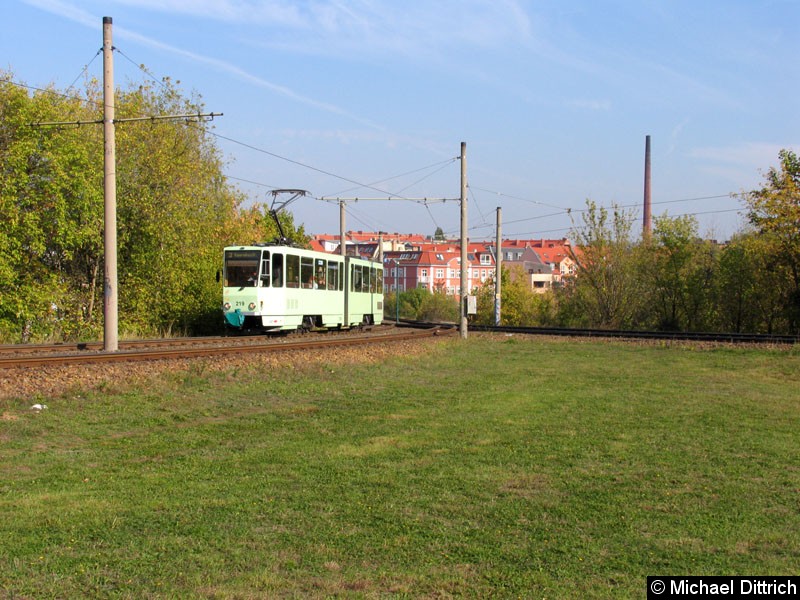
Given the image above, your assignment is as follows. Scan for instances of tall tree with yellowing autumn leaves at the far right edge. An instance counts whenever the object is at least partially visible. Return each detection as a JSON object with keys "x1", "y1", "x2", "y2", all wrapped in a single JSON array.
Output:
[{"x1": 745, "y1": 150, "x2": 800, "y2": 333}]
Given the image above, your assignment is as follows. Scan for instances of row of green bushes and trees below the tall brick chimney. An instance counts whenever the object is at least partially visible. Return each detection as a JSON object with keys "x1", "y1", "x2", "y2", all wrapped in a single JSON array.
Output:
[{"x1": 428, "y1": 150, "x2": 800, "y2": 335}]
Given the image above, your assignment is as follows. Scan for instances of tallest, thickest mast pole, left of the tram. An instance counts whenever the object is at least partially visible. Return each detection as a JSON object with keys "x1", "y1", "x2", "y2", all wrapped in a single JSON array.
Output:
[{"x1": 103, "y1": 17, "x2": 119, "y2": 352}]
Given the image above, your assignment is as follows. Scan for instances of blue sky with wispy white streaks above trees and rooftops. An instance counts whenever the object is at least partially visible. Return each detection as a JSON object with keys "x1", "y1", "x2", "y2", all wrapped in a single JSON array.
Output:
[{"x1": 0, "y1": 0, "x2": 800, "y2": 240}]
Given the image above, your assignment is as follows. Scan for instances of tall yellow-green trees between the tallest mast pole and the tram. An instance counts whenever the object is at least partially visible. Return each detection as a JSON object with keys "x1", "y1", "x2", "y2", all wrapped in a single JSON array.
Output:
[{"x1": 111, "y1": 81, "x2": 242, "y2": 332}]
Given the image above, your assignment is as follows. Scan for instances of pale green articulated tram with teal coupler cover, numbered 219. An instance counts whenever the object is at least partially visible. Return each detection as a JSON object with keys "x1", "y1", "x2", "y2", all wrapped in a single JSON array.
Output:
[{"x1": 222, "y1": 244, "x2": 383, "y2": 332}]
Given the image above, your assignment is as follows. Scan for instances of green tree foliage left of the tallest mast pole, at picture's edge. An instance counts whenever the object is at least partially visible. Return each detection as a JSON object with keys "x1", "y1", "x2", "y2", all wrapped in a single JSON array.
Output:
[{"x1": 0, "y1": 75, "x2": 102, "y2": 339}]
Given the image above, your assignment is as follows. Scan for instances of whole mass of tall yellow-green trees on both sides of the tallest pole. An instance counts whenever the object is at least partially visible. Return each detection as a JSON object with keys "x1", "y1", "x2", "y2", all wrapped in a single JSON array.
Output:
[{"x1": 0, "y1": 74, "x2": 307, "y2": 340}]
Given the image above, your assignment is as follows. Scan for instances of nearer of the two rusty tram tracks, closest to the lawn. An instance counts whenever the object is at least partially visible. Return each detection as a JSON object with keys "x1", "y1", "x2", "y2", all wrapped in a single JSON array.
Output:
[{"x1": 0, "y1": 327, "x2": 450, "y2": 369}]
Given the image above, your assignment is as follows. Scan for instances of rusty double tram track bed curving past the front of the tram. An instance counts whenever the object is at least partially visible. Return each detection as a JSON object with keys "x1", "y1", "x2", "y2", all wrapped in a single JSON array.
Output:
[{"x1": 0, "y1": 326, "x2": 450, "y2": 369}]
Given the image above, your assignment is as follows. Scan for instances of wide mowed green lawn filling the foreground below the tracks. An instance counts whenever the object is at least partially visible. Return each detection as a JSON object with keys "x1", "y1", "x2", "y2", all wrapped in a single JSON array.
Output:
[{"x1": 0, "y1": 335, "x2": 800, "y2": 598}]
